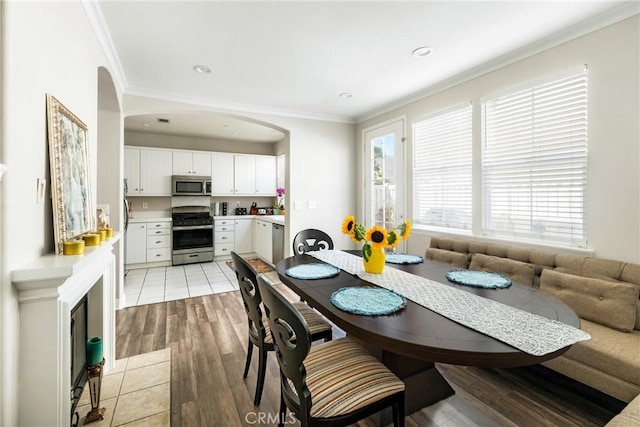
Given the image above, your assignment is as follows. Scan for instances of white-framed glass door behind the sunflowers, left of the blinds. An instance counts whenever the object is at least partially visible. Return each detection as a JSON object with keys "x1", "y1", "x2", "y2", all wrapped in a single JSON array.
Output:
[{"x1": 364, "y1": 118, "x2": 405, "y2": 251}]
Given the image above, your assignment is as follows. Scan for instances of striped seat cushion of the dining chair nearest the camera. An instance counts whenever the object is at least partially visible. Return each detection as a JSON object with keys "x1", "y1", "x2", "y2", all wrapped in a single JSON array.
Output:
[{"x1": 302, "y1": 337, "x2": 404, "y2": 418}]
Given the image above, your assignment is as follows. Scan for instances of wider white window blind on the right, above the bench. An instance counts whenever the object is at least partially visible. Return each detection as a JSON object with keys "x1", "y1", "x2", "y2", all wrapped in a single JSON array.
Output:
[{"x1": 482, "y1": 69, "x2": 587, "y2": 247}]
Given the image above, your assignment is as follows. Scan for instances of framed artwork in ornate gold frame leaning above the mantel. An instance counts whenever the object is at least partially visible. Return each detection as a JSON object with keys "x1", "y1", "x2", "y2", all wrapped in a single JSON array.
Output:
[{"x1": 47, "y1": 94, "x2": 96, "y2": 254}]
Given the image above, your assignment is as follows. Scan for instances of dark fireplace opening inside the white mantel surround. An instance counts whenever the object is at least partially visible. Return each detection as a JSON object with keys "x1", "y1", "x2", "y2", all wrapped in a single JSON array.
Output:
[{"x1": 71, "y1": 295, "x2": 88, "y2": 426}]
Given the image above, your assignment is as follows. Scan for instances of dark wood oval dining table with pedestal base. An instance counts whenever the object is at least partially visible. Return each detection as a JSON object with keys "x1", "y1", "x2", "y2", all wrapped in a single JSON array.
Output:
[{"x1": 276, "y1": 251, "x2": 580, "y2": 414}]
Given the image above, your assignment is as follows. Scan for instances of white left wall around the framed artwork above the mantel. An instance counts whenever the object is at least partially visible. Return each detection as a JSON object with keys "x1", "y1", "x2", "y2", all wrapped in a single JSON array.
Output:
[{"x1": 0, "y1": 1, "x2": 119, "y2": 426}]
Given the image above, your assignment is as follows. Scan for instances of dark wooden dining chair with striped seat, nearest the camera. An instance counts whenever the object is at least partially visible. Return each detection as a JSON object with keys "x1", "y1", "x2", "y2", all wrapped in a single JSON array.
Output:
[{"x1": 258, "y1": 274, "x2": 405, "y2": 427}]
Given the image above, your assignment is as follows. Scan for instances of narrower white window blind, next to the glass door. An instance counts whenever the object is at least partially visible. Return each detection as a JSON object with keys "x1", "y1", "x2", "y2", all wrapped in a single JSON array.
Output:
[{"x1": 413, "y1": 104, "x2": 472, "y2": 232}]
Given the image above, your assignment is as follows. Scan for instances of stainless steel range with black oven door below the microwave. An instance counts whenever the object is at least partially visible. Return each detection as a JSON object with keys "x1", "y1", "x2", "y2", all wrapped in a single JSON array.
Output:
[{"x1": 171, "y1": 211, "x2": 213, "y2": 265}]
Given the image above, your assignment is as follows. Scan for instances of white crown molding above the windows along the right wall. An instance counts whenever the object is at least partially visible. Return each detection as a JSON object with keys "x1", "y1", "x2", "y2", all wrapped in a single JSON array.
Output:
[{"x1": 356, "y1": 1, "x2": 640, "y2": 123}]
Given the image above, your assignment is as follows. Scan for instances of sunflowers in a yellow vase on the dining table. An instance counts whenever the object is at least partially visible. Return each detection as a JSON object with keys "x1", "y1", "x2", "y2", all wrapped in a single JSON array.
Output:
[{"x1": 342, "y1": 215, "x2": 411, "y2": 274}]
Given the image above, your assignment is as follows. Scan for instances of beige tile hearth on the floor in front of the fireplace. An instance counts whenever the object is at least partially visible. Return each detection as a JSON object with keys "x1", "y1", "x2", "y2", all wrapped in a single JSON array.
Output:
[{"x1": 76, "y1": 348, "x2": 171, "y2": 427}]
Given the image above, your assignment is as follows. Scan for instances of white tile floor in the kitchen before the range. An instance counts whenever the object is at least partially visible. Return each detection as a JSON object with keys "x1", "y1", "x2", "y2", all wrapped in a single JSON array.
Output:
[{"x1": 124, "y1": 261, "x2": 238, "y2": 307}]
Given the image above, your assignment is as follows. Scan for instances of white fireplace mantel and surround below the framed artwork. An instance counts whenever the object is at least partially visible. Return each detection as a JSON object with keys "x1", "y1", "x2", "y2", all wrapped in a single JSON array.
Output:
[{"x1": 11, "y1": 233, "x2": 122, "y2": 426}]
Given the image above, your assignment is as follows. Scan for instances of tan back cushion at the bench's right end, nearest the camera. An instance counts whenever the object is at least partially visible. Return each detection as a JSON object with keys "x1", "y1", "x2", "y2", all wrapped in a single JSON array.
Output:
[{"x1": 540, "y1": 270, "x2": 638, "y2": 332}]
